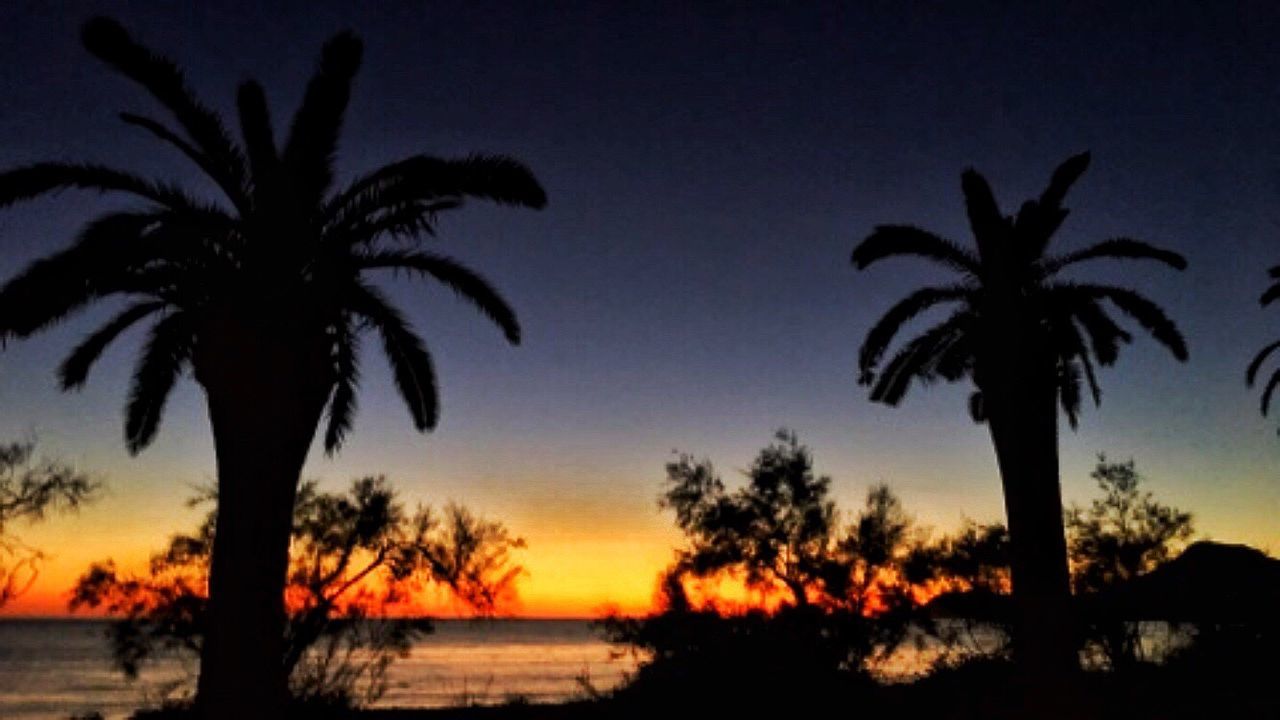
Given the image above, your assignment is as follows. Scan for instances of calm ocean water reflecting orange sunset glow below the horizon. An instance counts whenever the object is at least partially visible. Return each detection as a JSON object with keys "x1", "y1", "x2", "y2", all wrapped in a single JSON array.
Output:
[{"x1": 0, "y1": 619, "x2": 635, "y2": 720}]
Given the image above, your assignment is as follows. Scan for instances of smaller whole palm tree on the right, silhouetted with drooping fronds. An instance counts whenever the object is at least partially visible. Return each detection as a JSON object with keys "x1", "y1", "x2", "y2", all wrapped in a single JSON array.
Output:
[{"x1": 852, "y1": 154, "x2": 1187, "y2": 678}]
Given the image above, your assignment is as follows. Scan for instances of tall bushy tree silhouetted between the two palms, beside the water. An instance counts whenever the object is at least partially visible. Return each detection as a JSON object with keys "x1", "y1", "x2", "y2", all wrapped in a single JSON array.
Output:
[{"x1": 602, "y1": 430, "x2": 914, "y2": 715}]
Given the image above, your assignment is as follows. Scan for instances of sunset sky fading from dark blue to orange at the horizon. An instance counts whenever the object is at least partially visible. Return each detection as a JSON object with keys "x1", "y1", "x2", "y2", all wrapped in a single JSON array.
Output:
[{"x1": 0, "y1": 1, "x2": 1280, "y2": 616}]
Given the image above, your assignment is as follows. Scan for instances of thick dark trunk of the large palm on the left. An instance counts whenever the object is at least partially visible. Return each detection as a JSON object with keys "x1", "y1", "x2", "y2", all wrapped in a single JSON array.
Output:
[{"x1": 196, "y1": 320, "x2": 328, "y2": 720}]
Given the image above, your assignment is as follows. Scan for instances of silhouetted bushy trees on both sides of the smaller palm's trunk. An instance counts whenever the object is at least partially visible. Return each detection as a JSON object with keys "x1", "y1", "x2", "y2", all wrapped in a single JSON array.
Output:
[{"x1": 603, "y1": 430, "x2": 1194, "y2": 703}]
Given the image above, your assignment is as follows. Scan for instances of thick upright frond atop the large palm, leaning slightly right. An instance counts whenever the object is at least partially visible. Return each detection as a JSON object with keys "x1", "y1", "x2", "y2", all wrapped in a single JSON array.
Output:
[{"x1": 280, "y1": 31, "x2": 364, "y2": 205}]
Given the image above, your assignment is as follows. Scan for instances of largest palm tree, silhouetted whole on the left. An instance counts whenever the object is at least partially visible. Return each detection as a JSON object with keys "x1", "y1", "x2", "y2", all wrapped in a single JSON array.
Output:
[{"x1": 0, "y1": 18, "x2": 547, "y2": 717}]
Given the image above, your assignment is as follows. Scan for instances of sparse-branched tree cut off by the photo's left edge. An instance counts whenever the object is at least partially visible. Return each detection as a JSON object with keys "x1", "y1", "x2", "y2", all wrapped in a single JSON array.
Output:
[{"x1": 0, "y1": 442, "x2": 101, "y2": 607}]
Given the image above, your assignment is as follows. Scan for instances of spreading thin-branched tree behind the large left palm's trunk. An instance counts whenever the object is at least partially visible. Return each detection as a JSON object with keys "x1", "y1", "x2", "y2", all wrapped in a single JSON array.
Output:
[{"x1": 70, "y1": 477, "x2": 524, "y2": 706}]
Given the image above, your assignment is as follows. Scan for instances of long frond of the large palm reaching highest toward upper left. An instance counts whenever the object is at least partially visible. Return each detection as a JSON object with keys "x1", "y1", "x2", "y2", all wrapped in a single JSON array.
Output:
[{"x1": 81, "y1": 17, "x2": 246, "y2": 206}]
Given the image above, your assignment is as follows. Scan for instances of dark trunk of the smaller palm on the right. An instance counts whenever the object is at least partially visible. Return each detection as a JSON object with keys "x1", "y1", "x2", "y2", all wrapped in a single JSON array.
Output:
[{"x1": 983, "y1": 363, "x2": 1079, "y2": 694}]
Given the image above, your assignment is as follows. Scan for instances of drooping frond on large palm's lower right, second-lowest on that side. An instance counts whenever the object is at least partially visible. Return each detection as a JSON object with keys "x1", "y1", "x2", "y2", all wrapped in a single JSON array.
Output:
[{"x1": 347, "y1": 284, "x2": 439, "y2": 430}]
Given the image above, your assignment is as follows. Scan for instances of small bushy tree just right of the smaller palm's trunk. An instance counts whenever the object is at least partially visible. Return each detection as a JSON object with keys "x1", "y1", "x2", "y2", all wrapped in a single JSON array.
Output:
[{"x1": 1066, "y1": 455, "x2": 1196, "y2": 669}]
